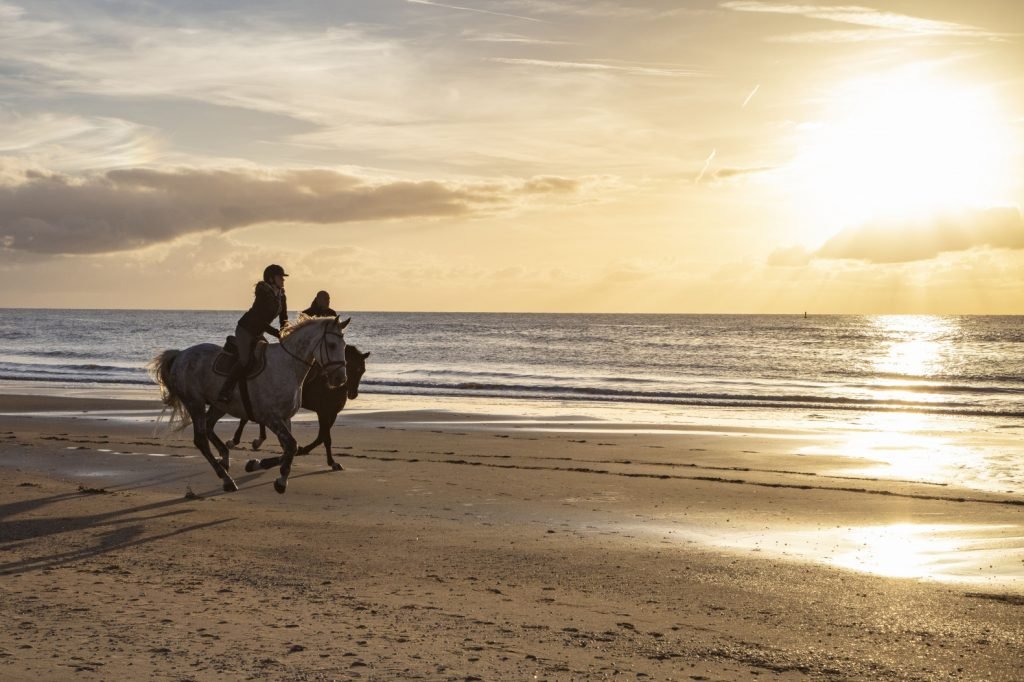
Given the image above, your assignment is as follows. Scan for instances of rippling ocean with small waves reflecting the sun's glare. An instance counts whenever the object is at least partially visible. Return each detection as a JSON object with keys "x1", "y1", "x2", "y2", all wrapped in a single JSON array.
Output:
[{"x1": 0, "y1": 309, "x2": 1024, "y2": 420}]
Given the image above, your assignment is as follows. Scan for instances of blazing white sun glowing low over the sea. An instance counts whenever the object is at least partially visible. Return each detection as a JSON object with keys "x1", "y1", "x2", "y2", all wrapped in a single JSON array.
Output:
[{"x1": 797, "y1": 70, "x2": 1011, "y2": 225}]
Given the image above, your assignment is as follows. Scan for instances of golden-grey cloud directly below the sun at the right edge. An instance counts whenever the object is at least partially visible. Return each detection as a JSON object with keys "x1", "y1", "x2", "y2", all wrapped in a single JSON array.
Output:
[{"x1": 814, "y1": 207, "x2": 1024, "y2": 263}]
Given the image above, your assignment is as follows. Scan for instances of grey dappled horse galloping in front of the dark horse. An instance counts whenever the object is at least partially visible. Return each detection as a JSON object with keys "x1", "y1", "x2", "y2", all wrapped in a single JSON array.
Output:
[{"x1": 150, "y1": 317, "x2": 350, "y2": 493}]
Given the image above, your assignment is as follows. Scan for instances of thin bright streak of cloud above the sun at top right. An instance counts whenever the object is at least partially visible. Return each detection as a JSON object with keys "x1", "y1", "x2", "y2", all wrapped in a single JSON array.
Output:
[{"x1": 719, "y1": 0, "x2": 1004, "y2": 41}]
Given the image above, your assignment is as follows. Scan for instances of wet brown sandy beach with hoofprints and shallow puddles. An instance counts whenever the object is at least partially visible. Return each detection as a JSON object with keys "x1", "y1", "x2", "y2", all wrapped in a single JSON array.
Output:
[{"x1": 0, "y1": 396, "x2": 1024, "y2": 680}]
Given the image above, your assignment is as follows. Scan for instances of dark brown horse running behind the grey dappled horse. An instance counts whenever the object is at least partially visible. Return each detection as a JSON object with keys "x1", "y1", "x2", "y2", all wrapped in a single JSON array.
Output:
[{"x1": 227, "y1": 346, "x2": 370, "y2": 471}]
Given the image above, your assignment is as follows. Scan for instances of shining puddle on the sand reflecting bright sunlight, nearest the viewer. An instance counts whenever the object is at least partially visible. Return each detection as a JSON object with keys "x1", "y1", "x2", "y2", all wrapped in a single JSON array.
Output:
[{"x1": 647, "y1": 523, "x2": 1024, "y2": 591}]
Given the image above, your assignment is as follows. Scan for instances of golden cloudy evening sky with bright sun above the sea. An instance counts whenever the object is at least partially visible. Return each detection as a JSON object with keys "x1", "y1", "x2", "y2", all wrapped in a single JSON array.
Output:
[{"x1": 0, "y1": 0, "x2": 1024, "y2": 314}]
